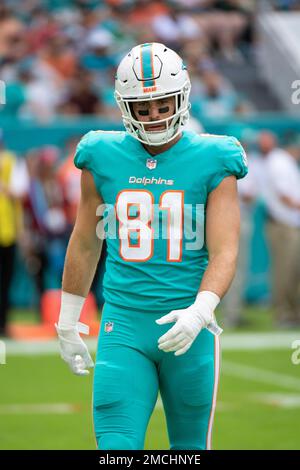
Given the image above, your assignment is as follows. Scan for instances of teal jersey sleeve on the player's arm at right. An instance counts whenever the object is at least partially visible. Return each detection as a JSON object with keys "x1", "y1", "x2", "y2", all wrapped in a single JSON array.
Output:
[{"x1": 208, "y1": 137, "x2": 248, "y2": 192}]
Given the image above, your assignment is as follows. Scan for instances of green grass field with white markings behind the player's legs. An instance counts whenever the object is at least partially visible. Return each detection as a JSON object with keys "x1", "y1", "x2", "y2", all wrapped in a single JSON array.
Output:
[{"x1": 0, "y1": 306, "x2": 300, "y2": 449}]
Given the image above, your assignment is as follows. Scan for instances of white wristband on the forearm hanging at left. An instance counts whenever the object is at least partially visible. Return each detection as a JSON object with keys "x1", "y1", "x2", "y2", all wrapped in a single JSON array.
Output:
[{"x1": 58, "y1": 291, "x2": 85, "y2": 329}]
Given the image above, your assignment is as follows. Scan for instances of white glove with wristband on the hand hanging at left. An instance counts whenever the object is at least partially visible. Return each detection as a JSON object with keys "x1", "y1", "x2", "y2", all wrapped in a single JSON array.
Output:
[{"x1": 55, "y1": 292, "x2": 94, "y2": 375}]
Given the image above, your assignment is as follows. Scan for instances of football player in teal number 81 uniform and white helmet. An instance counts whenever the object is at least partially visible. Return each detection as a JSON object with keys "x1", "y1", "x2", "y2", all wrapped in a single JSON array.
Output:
[{"x1": 57, "y1": 43, "x2": 247, "y2": 450}]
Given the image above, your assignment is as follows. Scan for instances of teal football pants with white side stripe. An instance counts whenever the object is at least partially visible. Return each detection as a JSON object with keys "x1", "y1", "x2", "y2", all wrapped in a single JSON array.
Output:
[{"x1": 93, "y1": 303, "x2": 219, "y2": 450}]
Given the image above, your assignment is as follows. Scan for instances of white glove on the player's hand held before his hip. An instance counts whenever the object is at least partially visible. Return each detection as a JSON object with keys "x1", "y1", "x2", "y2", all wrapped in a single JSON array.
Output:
[{"x1": 156, "y1": 291, "x2": 222, "y2": 356}]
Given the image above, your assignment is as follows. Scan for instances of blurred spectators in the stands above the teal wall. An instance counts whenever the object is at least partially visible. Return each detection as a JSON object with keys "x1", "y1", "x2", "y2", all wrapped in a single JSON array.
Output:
[{"x1": 0, "y1": 0, "x2": 256, "y2": 121}]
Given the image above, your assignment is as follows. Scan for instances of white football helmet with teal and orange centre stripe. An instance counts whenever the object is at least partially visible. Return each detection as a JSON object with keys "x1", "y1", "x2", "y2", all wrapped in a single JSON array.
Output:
[{"x1": 115, "y1": 42, "x2": 191, "y2": 145}]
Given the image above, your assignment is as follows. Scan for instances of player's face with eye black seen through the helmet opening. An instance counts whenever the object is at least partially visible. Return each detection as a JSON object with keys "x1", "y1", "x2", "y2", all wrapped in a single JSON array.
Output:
[{"x1": 132, "y1": 96, "x2": 175, "y2": 132}]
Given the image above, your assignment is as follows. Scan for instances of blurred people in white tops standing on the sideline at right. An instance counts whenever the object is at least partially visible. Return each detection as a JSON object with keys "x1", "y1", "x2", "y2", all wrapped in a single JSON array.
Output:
[{"x1": 223, "y1": 130, "x2": 300, "y2": 328}]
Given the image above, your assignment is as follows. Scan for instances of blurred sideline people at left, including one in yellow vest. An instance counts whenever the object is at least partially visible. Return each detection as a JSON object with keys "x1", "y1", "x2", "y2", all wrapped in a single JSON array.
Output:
[{"x1": 0, "y1": 129, "x2": 80, "y2": 334}]
